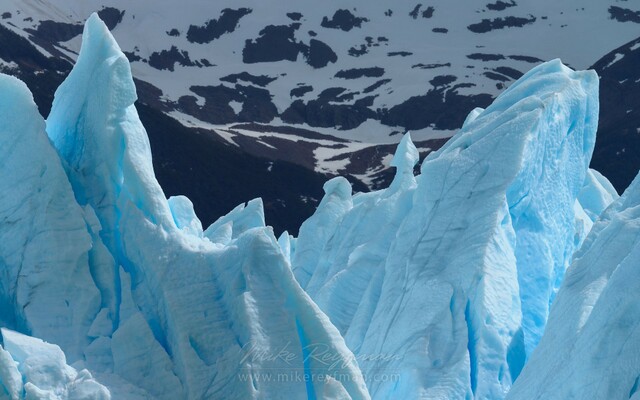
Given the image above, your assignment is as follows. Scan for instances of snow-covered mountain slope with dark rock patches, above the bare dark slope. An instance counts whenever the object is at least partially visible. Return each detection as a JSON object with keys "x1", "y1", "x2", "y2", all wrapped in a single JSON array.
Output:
[{"x1": 0, "y1": 0, "x2": 638, "y2": 180}]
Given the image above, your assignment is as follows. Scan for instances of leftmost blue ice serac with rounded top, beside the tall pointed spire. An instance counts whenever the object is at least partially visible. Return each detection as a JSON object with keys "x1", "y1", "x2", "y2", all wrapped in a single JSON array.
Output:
[{"x1": 0, "y1": 75, "x2": 108, "y2": 362}]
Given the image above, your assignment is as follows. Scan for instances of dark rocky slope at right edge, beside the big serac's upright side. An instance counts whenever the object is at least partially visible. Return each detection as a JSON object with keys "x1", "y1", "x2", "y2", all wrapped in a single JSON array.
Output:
[{"x1": 591, "y1": 38, "x2": 640, "y2": 193}]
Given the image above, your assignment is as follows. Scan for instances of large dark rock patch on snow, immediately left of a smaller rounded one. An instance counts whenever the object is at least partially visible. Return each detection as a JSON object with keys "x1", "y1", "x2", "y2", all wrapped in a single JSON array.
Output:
[{"x1": 242, "y1": 24, "x2": 306, "y2": 64}]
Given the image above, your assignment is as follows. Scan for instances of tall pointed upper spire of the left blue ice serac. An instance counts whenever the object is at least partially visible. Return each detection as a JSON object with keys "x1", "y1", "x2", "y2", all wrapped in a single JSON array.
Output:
[{"x1": 47, "y1": 14, "x2": 175, "y2": 250}]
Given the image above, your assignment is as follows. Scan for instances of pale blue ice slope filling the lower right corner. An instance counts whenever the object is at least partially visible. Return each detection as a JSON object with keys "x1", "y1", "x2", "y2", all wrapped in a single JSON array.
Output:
[{"x1": 507, "y1": 173, "x2": 640, "y2": 400}]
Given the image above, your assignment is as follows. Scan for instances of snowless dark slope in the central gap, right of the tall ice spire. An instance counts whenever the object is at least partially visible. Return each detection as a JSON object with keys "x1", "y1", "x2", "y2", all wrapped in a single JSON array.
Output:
[{"x1": 136, "y1": 103, "x2": 328, "y2": 235}]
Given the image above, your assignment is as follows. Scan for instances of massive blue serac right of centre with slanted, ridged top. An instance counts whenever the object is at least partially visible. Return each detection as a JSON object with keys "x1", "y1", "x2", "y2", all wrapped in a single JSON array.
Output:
[{"x1": 293, "y1": 60, "x2": 613, "y2": 399}]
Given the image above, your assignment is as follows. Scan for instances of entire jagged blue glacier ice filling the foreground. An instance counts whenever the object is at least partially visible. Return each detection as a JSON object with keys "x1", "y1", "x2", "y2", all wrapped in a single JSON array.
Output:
[{"x1": 0, "y1": 10, "x2": 640, "y2": 400}]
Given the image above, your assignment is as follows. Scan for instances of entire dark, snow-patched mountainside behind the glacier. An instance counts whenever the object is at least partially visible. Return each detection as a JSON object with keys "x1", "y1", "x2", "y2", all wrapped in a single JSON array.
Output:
[{"x1": 0, "y1": 0, "x2": 640, "y2": 233}]
